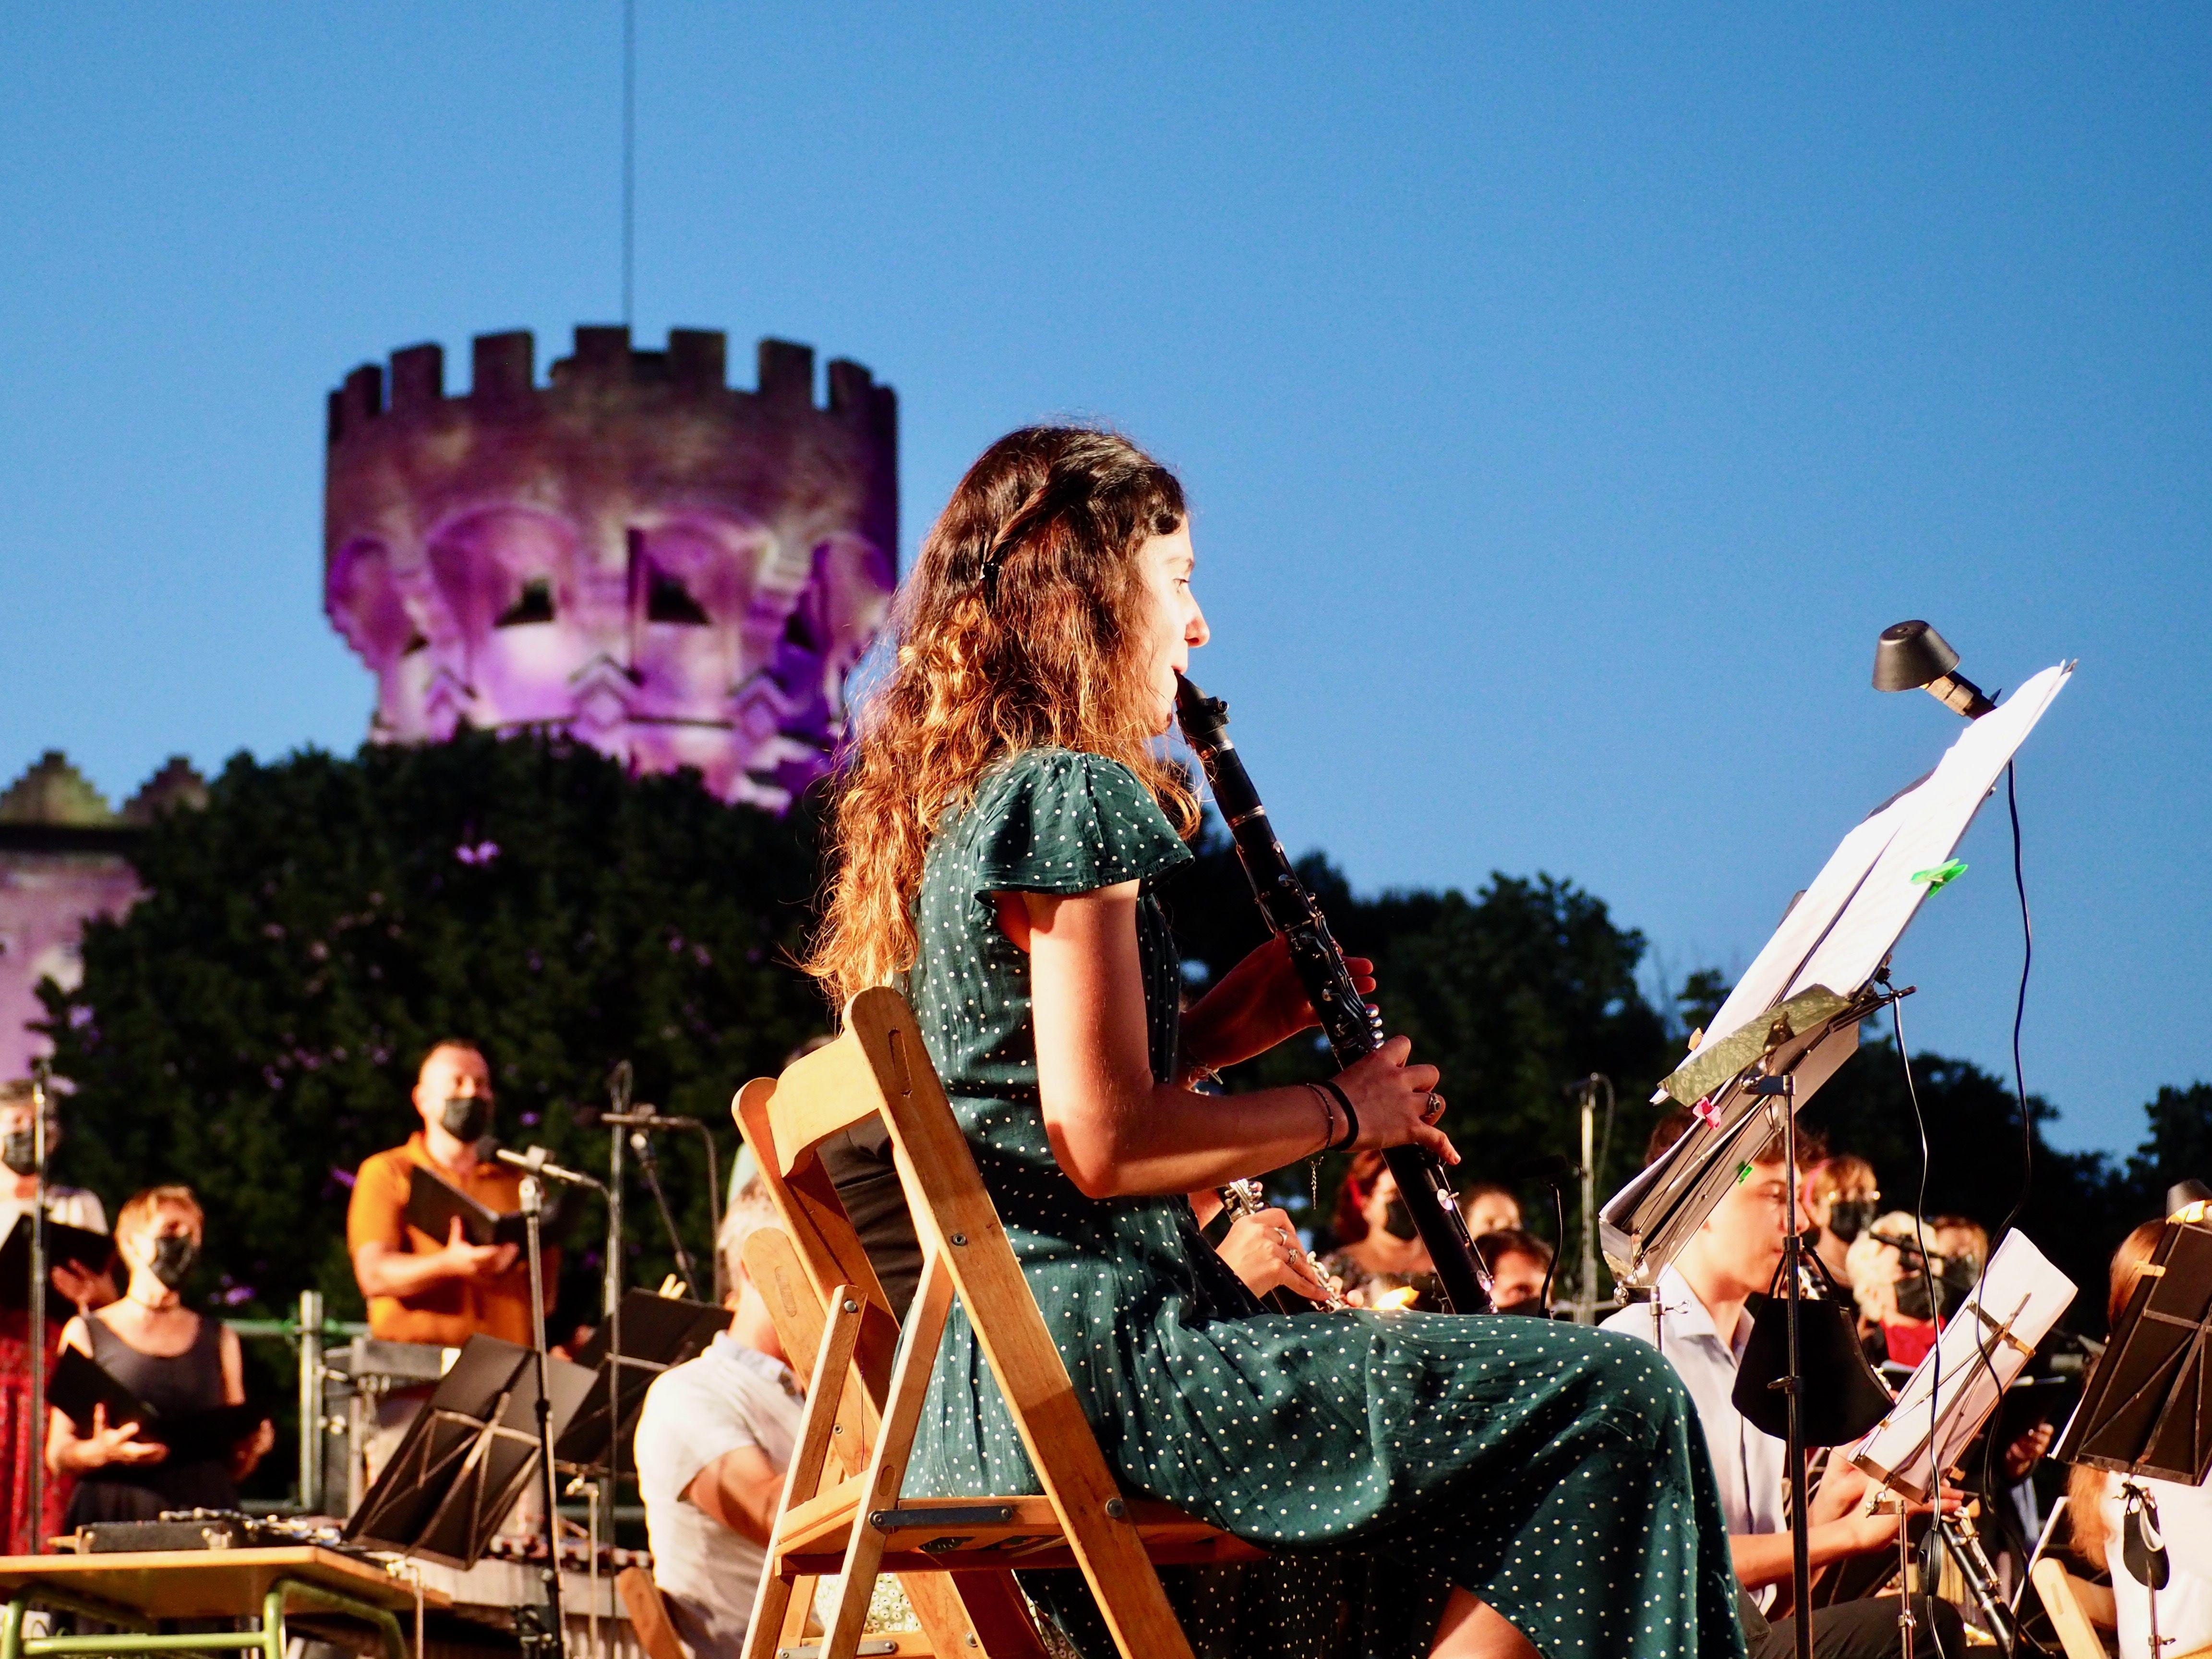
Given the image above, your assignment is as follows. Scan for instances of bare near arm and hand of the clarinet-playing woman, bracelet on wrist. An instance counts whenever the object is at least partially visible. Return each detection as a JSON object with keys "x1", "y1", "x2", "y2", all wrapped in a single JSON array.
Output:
[{"x1": 1009, "y1": 883, "x2": 1455, "y2": 1199}]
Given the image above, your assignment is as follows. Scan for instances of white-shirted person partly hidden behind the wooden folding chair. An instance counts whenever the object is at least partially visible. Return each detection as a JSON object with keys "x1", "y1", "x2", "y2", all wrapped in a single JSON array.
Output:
[{"x1": 637, "y1": 1181, "x2": 801, "y2": 1659}]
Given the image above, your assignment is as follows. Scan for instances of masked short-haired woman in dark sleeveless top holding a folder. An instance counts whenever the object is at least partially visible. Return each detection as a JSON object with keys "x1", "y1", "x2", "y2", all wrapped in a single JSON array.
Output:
[{"x1": 47, "y1": 1186, "x2": 274, "y2": 1527}]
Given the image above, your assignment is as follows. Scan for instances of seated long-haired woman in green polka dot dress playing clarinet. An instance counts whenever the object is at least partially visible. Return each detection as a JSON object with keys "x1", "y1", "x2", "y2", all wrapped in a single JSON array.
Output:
[{"x1": 812, "y1": 429, "x2": 1741, "y2": 1659}]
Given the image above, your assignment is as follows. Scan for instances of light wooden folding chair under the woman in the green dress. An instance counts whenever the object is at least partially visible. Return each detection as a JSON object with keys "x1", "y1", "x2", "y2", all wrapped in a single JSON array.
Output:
[{"x1": 732, "y1": 989, "x2": 1263, "y2": 1659}]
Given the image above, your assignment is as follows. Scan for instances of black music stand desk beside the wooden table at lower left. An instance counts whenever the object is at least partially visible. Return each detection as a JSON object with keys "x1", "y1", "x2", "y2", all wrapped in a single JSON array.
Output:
[{"x1": 345, "y1": 1336, "x2": 593, "y2": 1571}]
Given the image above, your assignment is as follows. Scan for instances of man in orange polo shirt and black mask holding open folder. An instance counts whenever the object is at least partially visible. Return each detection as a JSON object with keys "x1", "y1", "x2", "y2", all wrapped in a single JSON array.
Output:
[{"x1": 345, "y1": 1040, "x2": 560, "y2": 1347}]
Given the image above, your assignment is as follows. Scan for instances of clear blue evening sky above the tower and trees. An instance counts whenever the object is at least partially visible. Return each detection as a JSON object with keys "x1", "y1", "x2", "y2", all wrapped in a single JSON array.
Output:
[{"x1": 0, "y1": 0, "x2": 2212, "y2": 1150}]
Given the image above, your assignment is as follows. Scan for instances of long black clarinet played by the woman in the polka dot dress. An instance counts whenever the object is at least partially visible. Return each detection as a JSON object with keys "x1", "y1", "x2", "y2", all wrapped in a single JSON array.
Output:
[{"x1": 1175, "y1": 674, "x2": 1491, "y2": 1314}]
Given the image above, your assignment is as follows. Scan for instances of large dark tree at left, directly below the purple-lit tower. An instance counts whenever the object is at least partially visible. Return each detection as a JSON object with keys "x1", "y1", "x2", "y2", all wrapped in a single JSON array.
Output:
[{"x1": 47, "y1": 734, "x2": 825, "y2": 1318}]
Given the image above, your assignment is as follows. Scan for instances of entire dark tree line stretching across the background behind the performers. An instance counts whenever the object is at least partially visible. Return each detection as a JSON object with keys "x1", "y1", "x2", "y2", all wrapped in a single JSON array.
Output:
[{"x1": 26, "y1": 734, "x2": 2212, "y2": 1345}]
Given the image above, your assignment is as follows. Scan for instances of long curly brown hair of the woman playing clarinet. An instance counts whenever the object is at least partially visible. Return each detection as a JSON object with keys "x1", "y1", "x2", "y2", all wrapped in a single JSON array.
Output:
[{"x1": 805, "y1": 427, "x2": 1199, "y2": 1007}]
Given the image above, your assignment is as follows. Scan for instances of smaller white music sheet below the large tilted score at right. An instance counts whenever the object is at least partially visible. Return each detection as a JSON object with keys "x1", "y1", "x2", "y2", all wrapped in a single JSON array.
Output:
[{"x1": 1851, "y1": 1227, "x2": 2075, "y2": 1504}]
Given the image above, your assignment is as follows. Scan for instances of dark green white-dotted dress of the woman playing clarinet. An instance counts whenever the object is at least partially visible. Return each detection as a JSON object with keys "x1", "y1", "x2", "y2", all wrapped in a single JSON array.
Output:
[{"x1": 907, "y1": 750, "x2": 1743, "y2": 1659}]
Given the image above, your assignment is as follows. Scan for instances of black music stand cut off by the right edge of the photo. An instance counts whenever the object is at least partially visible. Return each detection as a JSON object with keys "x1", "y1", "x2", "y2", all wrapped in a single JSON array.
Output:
[{"x1": 2057, "y1": 1221, "x2": 2212, "y2": 1659}]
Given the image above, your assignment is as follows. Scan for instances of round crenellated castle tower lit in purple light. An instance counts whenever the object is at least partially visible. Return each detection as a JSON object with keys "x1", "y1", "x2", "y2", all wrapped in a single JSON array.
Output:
[{"x1": 323, "y1": 327, "x2": 898, "y2": 810}]
